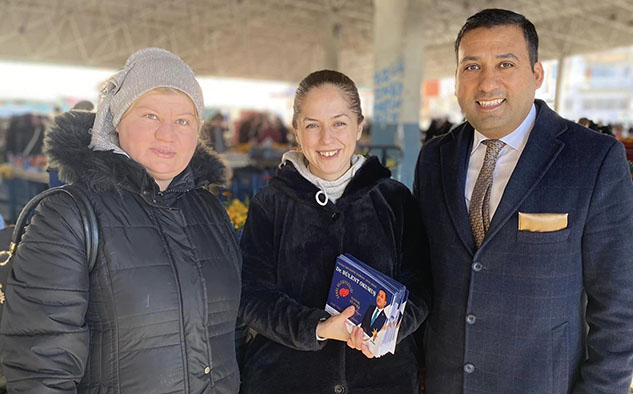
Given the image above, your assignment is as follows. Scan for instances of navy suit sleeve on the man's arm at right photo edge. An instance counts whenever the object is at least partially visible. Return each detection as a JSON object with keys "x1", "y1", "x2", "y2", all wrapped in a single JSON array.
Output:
[{"x1": 573, "y1": 142, "x2": 633, "y2": 394}]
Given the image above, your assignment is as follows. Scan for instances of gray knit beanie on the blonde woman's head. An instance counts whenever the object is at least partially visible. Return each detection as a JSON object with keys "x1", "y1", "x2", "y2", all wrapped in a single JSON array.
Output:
[{"x1": 90, "y1": 48, "x2": 204, "y2": 156}]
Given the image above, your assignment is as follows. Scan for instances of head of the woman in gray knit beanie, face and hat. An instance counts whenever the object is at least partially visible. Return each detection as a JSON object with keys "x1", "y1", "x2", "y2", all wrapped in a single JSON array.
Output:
[{"x1": 90, "y1": 48, "x2": 204, "y2": 190}]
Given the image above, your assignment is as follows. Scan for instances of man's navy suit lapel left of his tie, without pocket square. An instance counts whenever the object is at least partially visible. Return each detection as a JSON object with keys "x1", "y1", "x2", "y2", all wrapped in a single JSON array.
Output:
[{"x1": 440, "y1": 123, "x2": 475, "y2": 253}]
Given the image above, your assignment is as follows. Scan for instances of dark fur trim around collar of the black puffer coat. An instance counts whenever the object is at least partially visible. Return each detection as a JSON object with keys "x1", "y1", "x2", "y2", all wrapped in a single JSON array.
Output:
[{"x1": 44, "y1": 111, "x2": 227, "y2": 191}]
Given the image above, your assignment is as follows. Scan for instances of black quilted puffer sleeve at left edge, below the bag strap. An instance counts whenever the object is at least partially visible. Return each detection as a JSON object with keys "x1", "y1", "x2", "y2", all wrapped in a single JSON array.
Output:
[{"x1": 0, "y1": 195, "x2": 89, "y2": 394}]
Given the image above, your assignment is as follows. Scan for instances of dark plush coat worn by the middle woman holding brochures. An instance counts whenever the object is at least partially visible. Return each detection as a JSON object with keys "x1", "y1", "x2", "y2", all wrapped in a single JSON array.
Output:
[{"x1": 240, "y1": 157, "x2": 429, "y2": 394}]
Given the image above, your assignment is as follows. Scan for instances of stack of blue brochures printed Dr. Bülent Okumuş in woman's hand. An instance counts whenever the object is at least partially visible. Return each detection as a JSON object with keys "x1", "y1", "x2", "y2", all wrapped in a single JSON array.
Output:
[{"x1": 325, "y1": 254, "x2": 409, "y2": 357}]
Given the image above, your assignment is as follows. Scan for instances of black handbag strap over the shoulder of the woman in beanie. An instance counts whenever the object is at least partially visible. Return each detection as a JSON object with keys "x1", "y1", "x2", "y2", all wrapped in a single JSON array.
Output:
[{"x1": 0, "y1": 185, "x2": 99, "y2": 272}]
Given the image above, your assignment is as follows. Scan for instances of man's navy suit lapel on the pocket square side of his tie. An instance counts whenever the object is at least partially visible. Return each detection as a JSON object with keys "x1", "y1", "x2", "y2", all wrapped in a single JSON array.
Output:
[{"x1": 480, "y1": 100, "x2": 567, "y2": 249}]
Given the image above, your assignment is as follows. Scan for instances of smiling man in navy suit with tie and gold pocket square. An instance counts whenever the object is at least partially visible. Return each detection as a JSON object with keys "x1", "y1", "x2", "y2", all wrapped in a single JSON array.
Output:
[{"x1": 414, "y1": 9, "x2": 633, "y2": 394}]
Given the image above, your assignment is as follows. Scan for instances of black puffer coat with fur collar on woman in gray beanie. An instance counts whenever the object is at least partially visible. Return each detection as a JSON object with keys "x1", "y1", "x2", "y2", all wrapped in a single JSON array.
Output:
[{"x1": 1, "y1": 112, "x2": 241, "y2": 394}]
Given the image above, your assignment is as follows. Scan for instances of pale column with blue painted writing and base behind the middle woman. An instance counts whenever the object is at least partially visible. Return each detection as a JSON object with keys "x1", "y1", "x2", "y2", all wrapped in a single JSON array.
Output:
[{"x1": 371, "y1": 0, "x2": 424, "y2": 187}]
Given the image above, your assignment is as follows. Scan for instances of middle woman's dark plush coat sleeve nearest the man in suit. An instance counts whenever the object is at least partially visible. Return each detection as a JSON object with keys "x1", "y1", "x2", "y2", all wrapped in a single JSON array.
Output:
[{"x1": 398, "y1": 186, "x2": 431, "y2": 343}]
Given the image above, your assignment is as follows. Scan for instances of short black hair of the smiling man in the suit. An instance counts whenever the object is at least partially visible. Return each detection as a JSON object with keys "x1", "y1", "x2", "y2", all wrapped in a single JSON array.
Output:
[{"x1": 455, "y1": 8, "x2": 538, "y2": 69}]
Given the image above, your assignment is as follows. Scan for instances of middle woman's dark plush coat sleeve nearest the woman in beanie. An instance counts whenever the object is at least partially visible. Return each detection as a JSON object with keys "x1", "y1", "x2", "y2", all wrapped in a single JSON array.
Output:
[{"x1": 240, "y1": 195, "x2": 330, "y2": 351}]
